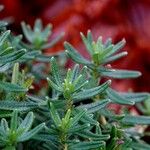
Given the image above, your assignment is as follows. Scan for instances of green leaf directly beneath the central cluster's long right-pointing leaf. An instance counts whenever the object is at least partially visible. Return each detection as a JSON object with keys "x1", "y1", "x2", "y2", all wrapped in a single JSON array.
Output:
[{"x1": 79, "y1": 99, "x2": 110, "y2": 113}]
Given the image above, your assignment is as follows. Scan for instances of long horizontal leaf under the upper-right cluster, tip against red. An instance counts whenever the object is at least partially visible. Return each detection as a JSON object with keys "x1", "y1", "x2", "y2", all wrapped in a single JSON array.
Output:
[{"x1": 98, "y1": 68, "x2": 141, "y2": 79}]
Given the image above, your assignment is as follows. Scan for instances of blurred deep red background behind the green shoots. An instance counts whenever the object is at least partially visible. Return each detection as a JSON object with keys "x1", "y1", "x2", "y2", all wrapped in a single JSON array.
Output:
[{"x1": 0, "y1": 0, "x2": 150, "y2": 92}]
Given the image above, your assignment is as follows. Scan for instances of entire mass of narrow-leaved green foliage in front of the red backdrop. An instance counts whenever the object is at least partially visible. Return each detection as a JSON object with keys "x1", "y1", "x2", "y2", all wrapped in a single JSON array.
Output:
[{"x1": 0, "y1": 5, "x2": 150, "y2": 150}]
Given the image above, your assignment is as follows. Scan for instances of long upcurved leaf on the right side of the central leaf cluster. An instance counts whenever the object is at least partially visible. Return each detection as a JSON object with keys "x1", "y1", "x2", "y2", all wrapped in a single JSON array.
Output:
[{"x1": 72, "y1": 80, "x2": 111, "y2": 102}]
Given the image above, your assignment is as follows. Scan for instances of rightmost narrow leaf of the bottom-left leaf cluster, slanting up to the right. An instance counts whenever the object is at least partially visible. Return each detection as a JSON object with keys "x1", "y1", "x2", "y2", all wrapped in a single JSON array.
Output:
[{"x1": 18, "y1": 123, "x2": 45, "y2": 142}]
